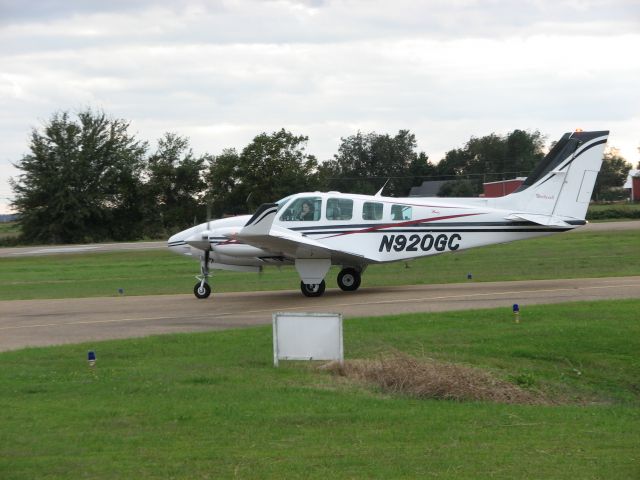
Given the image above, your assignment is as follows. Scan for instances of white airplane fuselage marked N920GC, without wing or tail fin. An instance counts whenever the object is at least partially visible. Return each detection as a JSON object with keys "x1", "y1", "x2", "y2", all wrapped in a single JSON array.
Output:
[{"x1": 169, "y1": 192, "x2": 585, "y2": 269}]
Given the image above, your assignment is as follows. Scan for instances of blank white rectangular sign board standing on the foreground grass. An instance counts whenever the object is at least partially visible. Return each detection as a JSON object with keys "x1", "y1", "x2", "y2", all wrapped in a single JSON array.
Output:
[{"x1": 273, "y1": 312, "x2": 344, "y2": 367}]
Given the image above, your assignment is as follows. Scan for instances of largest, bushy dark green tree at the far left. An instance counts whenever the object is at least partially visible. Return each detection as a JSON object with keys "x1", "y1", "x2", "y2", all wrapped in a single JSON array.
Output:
[{"x1": 11, "y1": 110, "x2": 147, "y2": 243}]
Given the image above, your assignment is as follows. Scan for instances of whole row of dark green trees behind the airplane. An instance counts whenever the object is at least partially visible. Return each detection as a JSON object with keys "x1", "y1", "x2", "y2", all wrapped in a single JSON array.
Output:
[{"x1": 11, "y1": 109, "x2": 630, "y2": 243}]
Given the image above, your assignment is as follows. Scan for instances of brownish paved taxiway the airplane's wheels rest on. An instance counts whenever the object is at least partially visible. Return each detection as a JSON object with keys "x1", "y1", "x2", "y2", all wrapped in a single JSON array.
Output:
[{"x1": 0, "y1": 276, "x2": 640, "y2": 351}]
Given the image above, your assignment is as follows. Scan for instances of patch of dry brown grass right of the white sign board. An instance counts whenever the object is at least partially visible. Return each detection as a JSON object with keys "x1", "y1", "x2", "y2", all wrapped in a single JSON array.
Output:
[{"x1": 325, "y1": 354, "x2": 548, "y2": 404}]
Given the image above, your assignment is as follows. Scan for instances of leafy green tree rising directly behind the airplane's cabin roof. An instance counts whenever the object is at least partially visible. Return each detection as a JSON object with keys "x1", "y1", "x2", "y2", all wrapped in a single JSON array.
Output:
[{"x1": 320, "y1": 130, "x2": 435, "y2": 196}]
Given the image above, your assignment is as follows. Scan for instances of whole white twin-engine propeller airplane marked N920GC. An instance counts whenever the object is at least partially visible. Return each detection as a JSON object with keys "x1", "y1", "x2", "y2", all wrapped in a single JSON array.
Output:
[{"x1": 168, "y1": 131, "x2": 609, "y2": 298}]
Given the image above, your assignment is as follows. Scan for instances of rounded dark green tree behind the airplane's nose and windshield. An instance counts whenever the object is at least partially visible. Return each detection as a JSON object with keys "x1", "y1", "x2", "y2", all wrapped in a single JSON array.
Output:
[{"x1": 207, "y1": 129, "x2": 318, "y2": 216}]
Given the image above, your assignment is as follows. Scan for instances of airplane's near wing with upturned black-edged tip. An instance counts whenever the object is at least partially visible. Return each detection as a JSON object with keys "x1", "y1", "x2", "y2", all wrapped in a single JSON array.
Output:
[{"x1": 235, "y1": 203, "x2": 372, "y2": 265}]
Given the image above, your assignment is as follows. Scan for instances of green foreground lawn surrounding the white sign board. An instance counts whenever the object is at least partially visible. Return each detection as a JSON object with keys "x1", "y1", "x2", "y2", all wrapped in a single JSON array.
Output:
[{"x1": 0, "y1": 300, "x2": 640, "y2": 480}]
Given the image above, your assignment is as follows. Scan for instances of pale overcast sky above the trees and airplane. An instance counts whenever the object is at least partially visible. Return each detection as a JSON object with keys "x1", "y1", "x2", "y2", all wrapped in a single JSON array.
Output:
[{"x1": 0, "y1": 0, "x2": 640, "y2": 213}]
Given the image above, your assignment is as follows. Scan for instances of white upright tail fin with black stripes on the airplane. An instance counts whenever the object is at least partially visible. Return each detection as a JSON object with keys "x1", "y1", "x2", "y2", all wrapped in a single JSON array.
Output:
[{"x1": 496, "y1": 131, "x2": 609, "y2": 224}]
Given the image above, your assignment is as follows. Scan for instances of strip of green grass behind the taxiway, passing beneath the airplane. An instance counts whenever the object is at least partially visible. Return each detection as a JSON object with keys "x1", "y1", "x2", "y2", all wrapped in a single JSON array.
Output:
[{"x1": 0, "y1": 227, "x2": 640, "y2": 300}]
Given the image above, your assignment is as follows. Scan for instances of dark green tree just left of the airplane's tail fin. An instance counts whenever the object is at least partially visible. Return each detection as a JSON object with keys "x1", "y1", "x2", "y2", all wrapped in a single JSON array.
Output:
[{"x1": 437, "y1": 130, "x2": 544, "y2": 194}]
